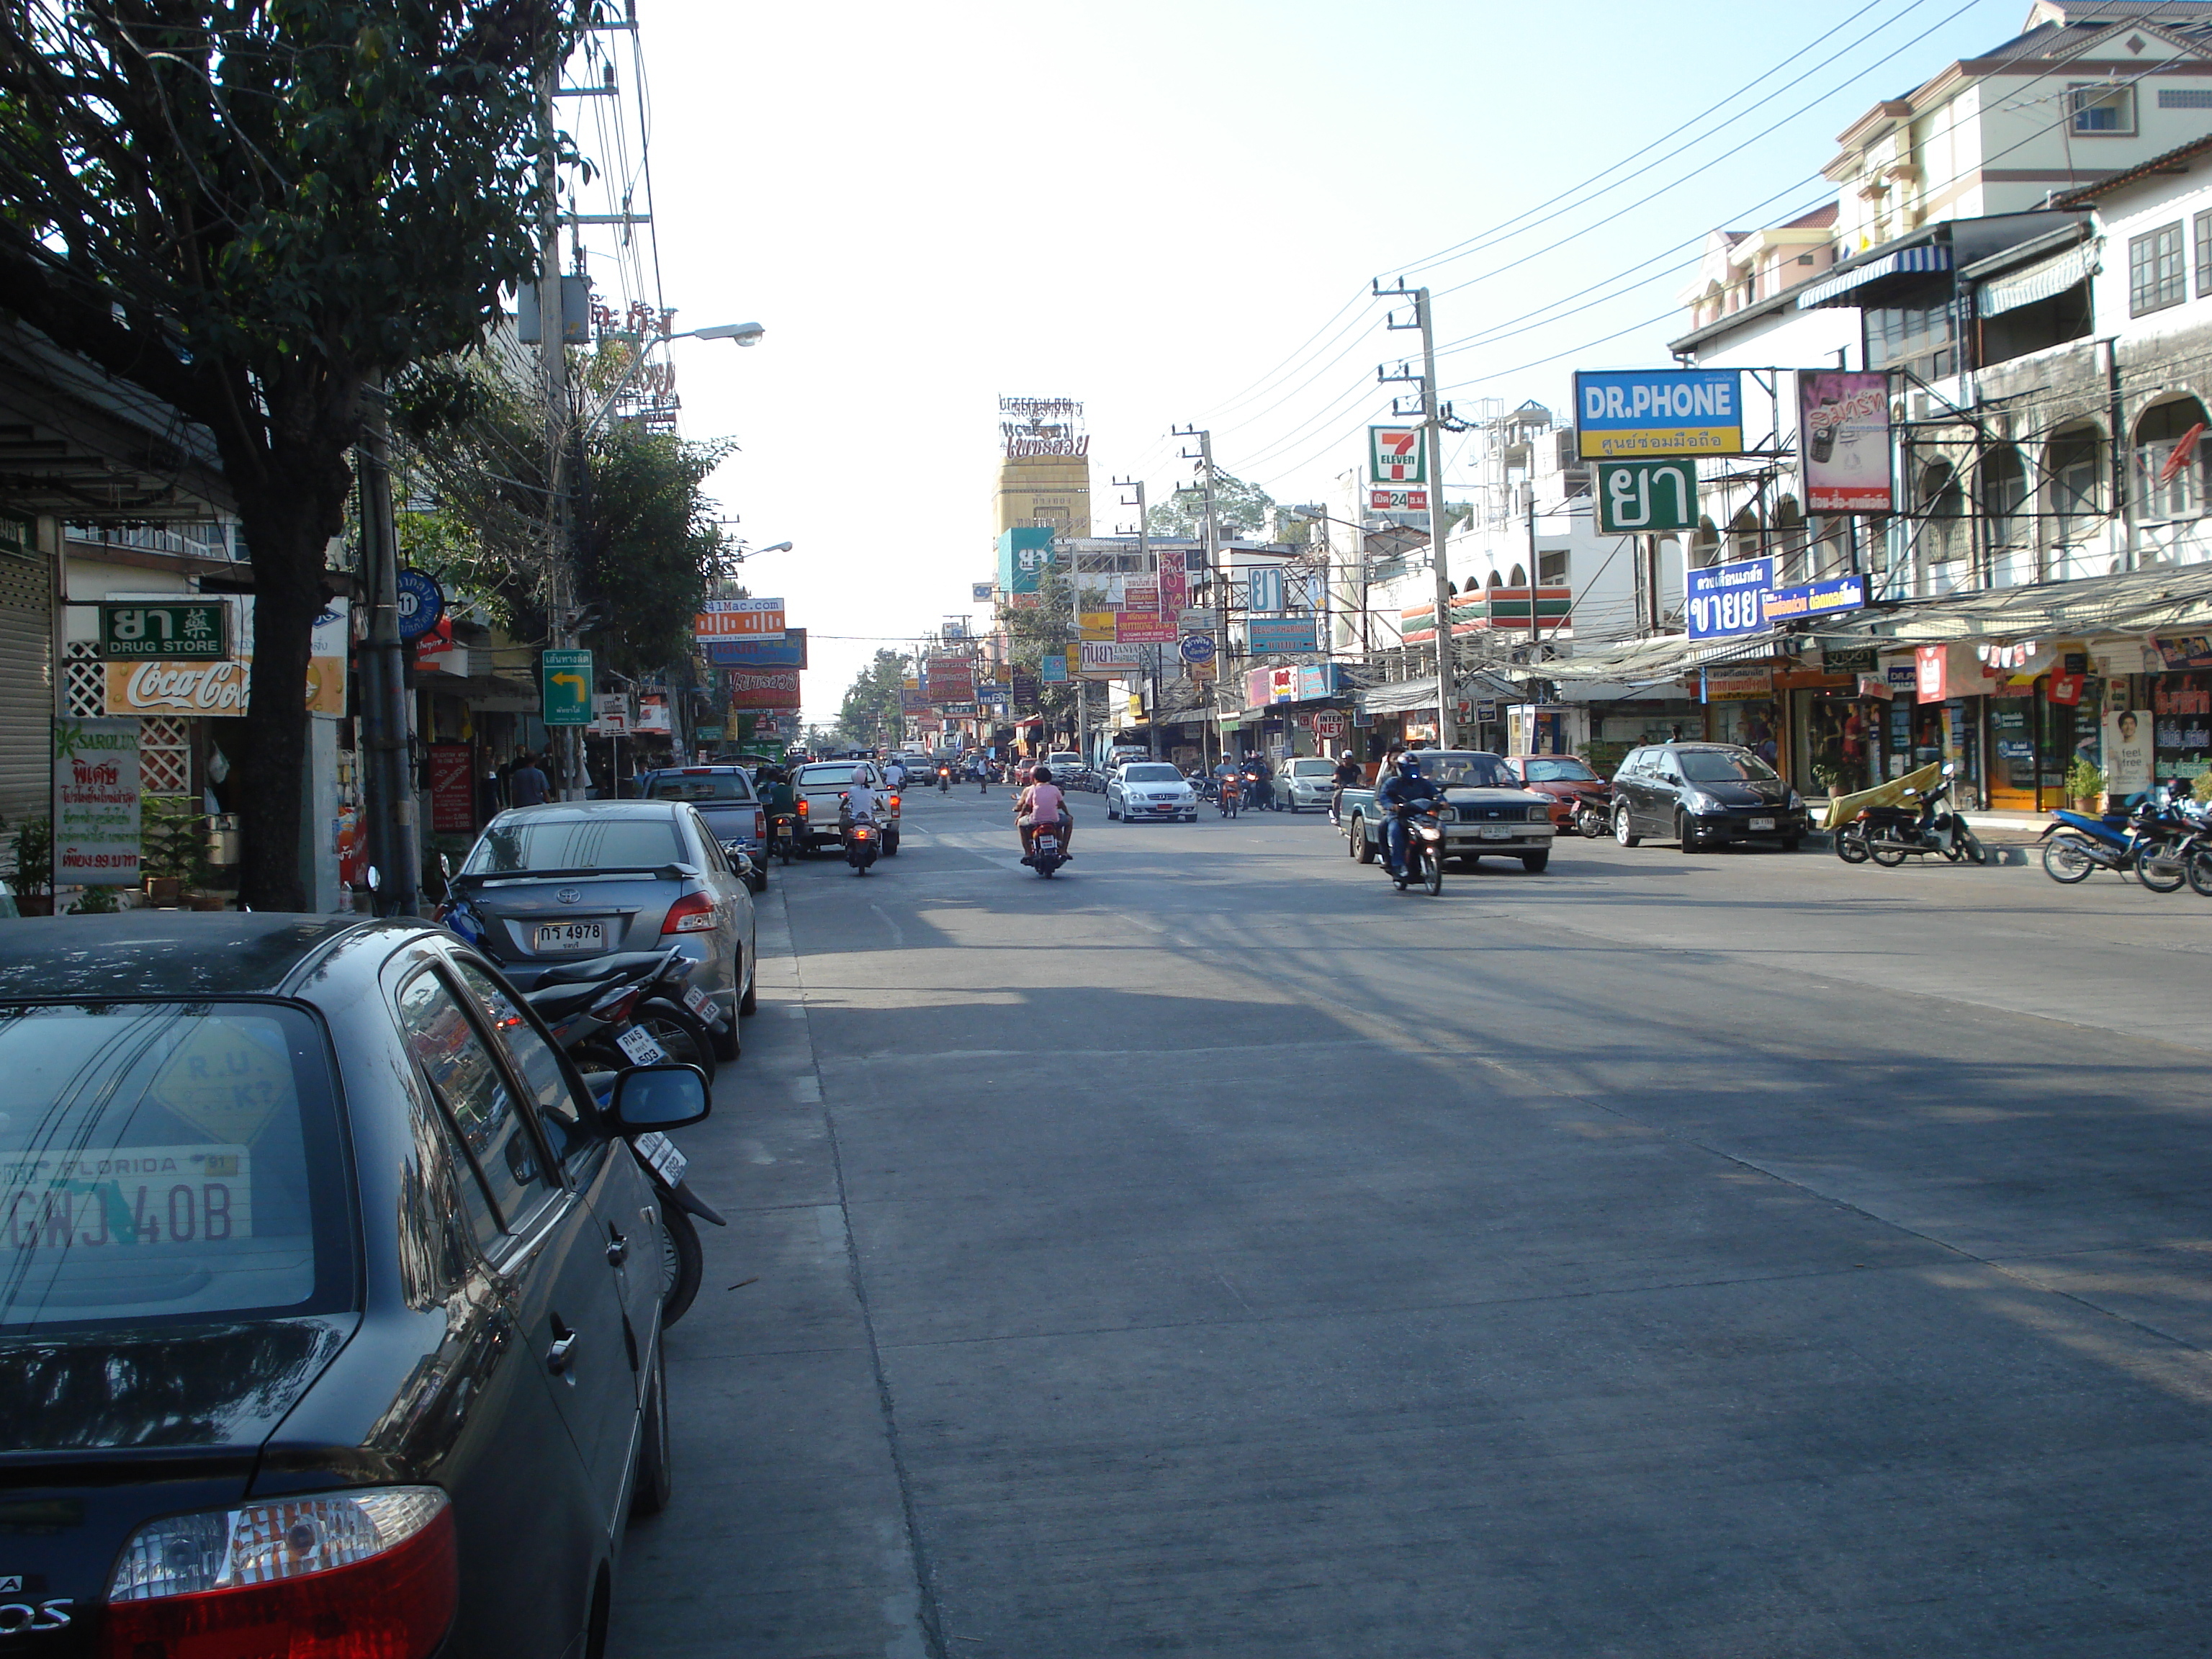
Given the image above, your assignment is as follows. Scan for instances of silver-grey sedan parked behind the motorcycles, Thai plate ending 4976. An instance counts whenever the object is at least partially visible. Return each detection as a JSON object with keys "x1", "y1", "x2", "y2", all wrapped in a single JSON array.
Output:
[{"x1": 451, "y1": 801, "x2": 757, "y2": 1059}]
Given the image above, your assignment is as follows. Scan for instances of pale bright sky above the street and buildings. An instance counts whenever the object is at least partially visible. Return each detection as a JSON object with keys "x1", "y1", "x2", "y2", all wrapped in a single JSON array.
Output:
[{"x1": 615, "y1": 0, "x2": 2028, "y2": 716}]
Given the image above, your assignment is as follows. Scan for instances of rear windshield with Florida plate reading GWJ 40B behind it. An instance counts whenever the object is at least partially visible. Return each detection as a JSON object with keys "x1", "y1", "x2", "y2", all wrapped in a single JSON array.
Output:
[{"x1": 0, "y1": 1002, "x2": 354, "y2": 1329}]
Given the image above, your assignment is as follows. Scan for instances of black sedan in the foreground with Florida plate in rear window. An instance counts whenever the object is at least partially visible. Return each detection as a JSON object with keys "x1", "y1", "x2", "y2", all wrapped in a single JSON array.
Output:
[{"x1": 0, "y1": 914, "x2": 706, "y2": 1659}]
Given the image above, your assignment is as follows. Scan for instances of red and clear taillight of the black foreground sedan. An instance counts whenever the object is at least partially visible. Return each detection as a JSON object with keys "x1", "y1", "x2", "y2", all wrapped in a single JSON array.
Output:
[{"x1": 99, "y1": 1486, "x2": 460, "y2": 1659}]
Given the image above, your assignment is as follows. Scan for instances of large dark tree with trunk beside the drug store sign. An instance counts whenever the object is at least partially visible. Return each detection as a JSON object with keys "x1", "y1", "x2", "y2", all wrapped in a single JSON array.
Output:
[{"x1": 0, "y1": 0, "x2": 590, "y2": 909}]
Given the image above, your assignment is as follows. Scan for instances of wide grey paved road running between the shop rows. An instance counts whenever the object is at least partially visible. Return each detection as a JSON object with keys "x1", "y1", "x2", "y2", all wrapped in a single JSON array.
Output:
[{"x1": 613, "y1": 792, "x2": 2212, "y2": 1659}]
